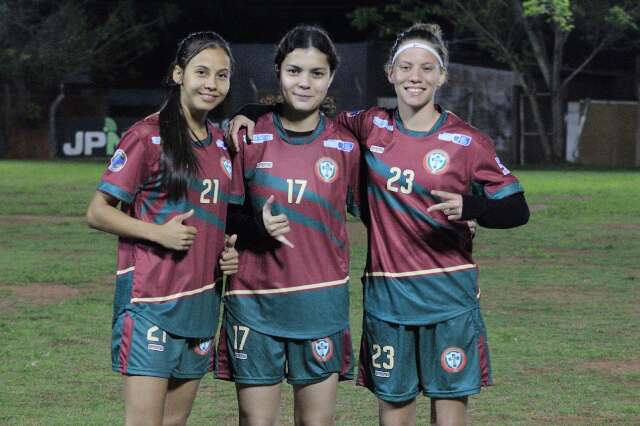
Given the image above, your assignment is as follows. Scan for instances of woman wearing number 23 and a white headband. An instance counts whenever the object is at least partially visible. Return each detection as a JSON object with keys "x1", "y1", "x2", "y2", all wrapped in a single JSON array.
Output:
[{"x1": 232, "y1": 23, "x2": 529, "y2": 425}]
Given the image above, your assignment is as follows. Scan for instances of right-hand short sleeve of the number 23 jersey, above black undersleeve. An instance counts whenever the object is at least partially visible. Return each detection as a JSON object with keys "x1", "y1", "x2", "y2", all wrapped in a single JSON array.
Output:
[{"x1": 471, "y1": 136, "x2": 524, "y2": 199}]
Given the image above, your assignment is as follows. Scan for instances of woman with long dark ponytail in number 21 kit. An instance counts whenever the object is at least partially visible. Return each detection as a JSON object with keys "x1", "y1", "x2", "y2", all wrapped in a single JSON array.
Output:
[{"x1": 87, "y1": 32, "x2": 243, "y2": 425}]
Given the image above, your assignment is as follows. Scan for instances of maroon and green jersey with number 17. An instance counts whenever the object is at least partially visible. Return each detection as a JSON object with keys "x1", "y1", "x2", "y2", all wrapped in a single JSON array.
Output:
[{"x1": 224, "y1": 113, "x2": 360, "y2": 339}]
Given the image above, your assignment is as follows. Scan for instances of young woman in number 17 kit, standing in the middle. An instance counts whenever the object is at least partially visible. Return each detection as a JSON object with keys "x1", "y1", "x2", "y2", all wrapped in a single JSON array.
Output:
[{"x1": 216, "y1": 26, "x2": 360, "y2": 425}]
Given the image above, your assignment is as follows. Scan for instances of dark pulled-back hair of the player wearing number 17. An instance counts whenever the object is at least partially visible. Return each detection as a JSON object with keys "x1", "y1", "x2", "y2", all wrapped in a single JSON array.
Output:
[{"x1": 274, "y1": 25, "x2": 340, "y2": 73}]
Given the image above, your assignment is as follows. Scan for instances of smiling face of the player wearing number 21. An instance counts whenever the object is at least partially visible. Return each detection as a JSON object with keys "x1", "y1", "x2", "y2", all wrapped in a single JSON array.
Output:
[{"x1": 173, "y1": 48, "x2": 231, "y2": 117}]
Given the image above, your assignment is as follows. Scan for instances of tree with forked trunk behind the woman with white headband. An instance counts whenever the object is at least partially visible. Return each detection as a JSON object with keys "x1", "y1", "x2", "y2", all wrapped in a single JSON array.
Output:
[{"x1": 350, "y1": 0, "x2": 640, "y2": 161}]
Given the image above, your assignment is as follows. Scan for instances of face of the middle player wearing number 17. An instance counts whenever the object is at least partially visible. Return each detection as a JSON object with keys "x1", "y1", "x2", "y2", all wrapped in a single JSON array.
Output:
[{"x1": 279, "y1": 47, "x2": 333, "y2": 113}]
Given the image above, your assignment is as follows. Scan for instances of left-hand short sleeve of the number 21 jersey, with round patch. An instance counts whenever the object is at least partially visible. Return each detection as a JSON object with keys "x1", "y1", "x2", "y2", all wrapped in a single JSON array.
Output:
[{"x1": 98, "y1": 128, "x2": 150, "y2": 204}]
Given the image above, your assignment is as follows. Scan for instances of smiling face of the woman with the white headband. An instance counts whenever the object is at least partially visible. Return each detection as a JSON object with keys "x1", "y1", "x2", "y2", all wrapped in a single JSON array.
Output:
[{"x1": 387, "y1": 40, "x2": 446, "y2": 110}]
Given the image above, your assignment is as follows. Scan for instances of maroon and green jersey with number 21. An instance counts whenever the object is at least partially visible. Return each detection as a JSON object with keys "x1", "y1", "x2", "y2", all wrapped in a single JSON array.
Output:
[{"x1": 98, "y1": 114, "x2": 243, "y2": 337}]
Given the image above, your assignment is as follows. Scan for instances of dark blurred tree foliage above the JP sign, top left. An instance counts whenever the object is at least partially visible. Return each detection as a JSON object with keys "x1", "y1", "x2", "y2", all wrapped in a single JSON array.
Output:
[{"x1": 0, "y1": 0, "x2": 178, "y2": 154}]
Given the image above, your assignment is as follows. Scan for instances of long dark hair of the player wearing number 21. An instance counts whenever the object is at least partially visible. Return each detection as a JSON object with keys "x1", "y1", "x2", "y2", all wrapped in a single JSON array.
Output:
[{"x1": 160, "y1": 31, "x2": 233, "y2": 201}]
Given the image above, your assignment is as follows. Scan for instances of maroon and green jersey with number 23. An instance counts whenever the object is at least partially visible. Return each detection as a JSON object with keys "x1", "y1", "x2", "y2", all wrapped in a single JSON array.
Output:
[{"x1": 338, "y1": 108, "x2": 523, "y2": 325}]
